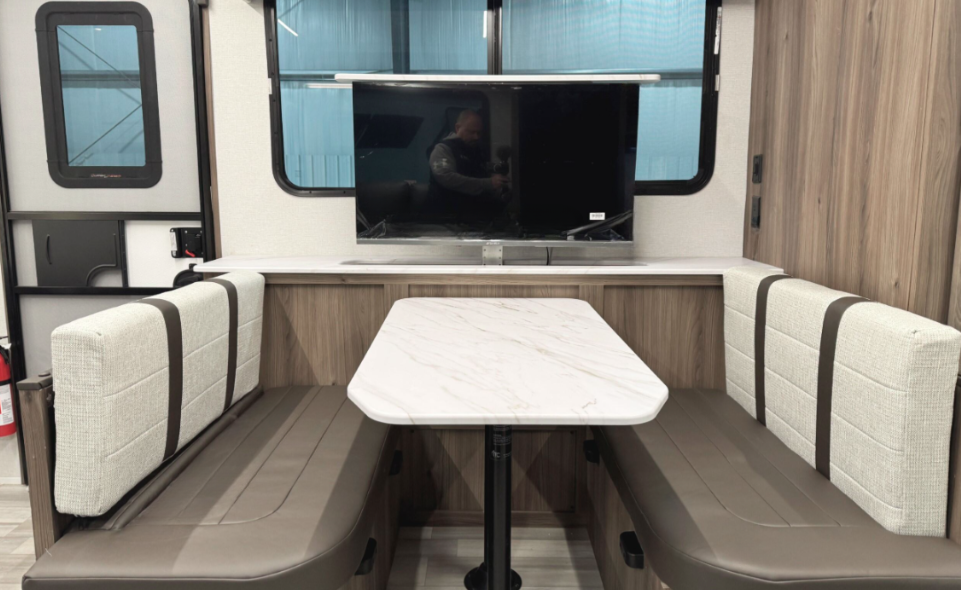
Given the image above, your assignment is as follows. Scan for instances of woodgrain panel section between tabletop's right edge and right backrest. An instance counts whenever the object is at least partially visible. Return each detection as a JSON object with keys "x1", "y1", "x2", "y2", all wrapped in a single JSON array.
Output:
[{"x1": 604, "y1": 287, "x2": 724, "y2": 389}]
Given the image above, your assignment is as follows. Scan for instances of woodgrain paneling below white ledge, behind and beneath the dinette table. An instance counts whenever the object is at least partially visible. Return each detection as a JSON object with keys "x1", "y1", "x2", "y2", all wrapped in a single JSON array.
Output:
[{"x1": 261, "y1": 277, "x2": 724, "y2": 526}]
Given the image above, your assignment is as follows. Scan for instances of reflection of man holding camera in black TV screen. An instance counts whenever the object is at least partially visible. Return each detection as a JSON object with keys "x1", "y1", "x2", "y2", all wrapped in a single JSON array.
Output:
[{"x1": 430, "y1": 110, "x2": 509, "y2": 221}]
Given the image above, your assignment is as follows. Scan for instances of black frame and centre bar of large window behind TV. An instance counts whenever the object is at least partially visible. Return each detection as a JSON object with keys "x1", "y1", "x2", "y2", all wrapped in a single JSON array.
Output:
[{"x1": 264, "y1": 0, "x2": 723, "y2": 197}]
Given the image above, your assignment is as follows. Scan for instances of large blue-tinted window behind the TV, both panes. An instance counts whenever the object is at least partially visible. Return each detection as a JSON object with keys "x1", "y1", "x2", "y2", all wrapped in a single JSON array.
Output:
[{"x1": 265, "y1": 0, "x2": 720, "y2": 195}]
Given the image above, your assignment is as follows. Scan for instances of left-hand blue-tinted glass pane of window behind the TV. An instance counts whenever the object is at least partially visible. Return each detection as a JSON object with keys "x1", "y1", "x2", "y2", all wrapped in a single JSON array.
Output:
[{"x1": 276, "y1": 0, "x2": 487, "y2": 188}]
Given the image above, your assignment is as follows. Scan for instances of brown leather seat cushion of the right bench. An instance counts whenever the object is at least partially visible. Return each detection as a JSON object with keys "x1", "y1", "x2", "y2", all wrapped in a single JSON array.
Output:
[{"x1": 594, "y1": 390, "x2": 961, "y2": 590}]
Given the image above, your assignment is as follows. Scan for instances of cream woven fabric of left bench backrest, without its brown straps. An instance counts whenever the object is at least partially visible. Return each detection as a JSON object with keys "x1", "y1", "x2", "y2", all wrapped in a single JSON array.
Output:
[{"x1": 52, "y1": 272, "x2": 264, "y2": 516}]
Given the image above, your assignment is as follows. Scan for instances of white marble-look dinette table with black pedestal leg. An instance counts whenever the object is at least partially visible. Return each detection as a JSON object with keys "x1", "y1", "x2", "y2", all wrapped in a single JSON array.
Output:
[{"x1": 347, "y1": 298, "x2": 668, "y2": 590}]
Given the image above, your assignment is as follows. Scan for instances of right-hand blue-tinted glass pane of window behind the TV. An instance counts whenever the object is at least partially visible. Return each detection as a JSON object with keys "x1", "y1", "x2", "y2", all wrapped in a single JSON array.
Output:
[{"x1": 503, "y1": 0, "x2": 706, "y2": 181}]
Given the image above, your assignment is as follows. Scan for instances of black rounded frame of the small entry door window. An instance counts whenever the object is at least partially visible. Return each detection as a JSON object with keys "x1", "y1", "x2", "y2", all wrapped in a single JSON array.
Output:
[{"x1": 36, "y1": 2, "x2": 163, "y2": 188}]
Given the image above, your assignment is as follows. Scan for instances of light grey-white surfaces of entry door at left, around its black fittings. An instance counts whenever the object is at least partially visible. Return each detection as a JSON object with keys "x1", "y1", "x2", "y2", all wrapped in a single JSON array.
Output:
[{"x1": 0, "y1": 0, "x2": 210, "y2": 386}]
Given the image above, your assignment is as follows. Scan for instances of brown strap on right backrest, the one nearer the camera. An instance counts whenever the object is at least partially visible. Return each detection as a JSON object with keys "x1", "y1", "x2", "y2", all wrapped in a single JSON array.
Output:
[{"x1": 814, "y1": 295, "x2": 867, "y2": 479}]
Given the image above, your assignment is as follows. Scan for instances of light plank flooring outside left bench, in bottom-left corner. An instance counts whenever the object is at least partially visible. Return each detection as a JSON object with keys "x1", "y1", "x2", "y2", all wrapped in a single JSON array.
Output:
[{"x1": 0, "y1": 488, "x2": 35, "y2": 590}]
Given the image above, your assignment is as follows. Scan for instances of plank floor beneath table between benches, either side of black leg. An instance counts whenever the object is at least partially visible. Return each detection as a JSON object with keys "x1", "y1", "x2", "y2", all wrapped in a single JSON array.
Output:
[{"x1": 390, "y1": 527, "x2": 603, "y2": 590}]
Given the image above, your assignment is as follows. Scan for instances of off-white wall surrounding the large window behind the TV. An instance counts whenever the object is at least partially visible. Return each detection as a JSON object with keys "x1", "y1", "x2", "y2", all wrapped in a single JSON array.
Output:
[{"x1": 210, "y1": 0, "x2": 754, "y2": 256}]
